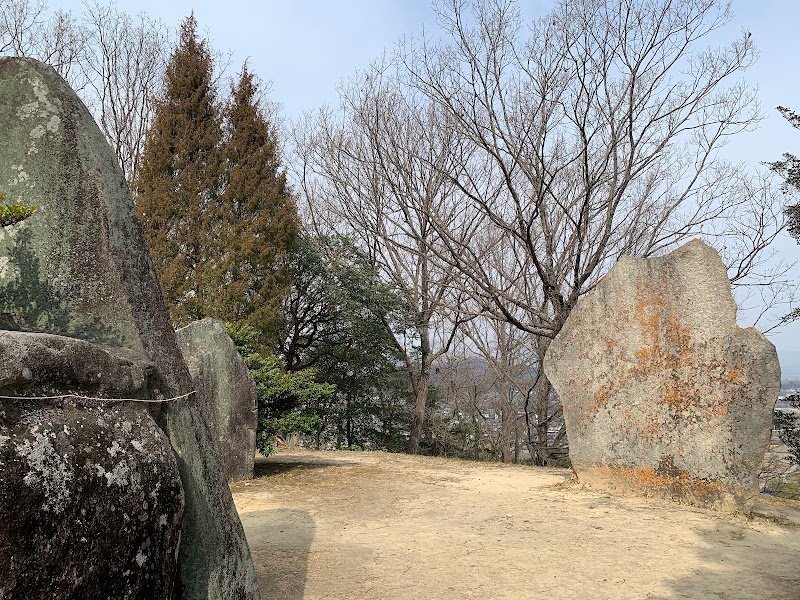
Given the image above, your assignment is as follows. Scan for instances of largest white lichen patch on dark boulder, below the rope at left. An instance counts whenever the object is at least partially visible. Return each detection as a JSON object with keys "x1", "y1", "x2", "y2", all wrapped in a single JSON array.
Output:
[{"x1": 15, "y1": 428, "x2": 73, "y2": 513}]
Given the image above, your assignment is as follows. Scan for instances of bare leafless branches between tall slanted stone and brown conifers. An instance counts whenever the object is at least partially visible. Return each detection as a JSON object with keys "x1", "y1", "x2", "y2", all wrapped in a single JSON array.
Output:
[{"x1": 0, "y1": 0, "x2": 174, "y2": 182}]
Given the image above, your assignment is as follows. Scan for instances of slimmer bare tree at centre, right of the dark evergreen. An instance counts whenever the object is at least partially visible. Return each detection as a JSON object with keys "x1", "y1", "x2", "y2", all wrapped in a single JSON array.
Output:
[{"x1": 298, "y1": 62, "x2": 476, "y2": 453}]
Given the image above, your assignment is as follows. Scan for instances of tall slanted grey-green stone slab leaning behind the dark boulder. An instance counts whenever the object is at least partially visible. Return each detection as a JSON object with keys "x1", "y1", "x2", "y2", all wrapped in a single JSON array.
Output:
[{"x1": 0, "y1": 58, "x2": 259, "y2": 600}]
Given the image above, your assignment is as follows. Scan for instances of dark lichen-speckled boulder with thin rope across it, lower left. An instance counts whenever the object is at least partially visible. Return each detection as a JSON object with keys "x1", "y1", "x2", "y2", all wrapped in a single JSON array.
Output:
[{"x1": 0, "y1": 332, "x2": 183, "y2": 600}]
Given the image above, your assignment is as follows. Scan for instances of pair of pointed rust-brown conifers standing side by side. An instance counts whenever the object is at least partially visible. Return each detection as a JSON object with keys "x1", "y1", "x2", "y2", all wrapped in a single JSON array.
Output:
[{"x1": 134, "y1": 16, "x2": 299, "y2": 345}]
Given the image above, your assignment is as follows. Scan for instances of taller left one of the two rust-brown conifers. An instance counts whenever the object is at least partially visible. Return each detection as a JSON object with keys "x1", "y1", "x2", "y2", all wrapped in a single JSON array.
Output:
[{"x1": 133, "y1": 15, "x2": 222, "y2": 325}]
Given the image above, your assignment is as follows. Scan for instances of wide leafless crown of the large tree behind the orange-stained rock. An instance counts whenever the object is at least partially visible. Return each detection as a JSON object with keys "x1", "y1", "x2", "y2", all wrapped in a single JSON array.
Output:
[{"x1": 397, "y1": 0, "x2": 784, "y2": 460}]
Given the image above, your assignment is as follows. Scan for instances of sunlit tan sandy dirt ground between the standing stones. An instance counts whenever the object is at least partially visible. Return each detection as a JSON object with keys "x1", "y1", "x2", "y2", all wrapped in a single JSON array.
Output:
[{"x1": 232, "y1": 451, "x2": 800, "y2": 600}]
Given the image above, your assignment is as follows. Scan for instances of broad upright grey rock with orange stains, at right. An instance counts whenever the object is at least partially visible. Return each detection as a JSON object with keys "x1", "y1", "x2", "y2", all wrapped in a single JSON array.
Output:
[{"x1": 544, "y1": 241, "x2": 780, "y2": 511}]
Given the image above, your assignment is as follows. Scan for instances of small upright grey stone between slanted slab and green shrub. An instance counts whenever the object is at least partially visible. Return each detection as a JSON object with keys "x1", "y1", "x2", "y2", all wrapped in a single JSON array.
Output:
[{"x1": 176, "y1": 319, "x2": 258, "y2": 481}]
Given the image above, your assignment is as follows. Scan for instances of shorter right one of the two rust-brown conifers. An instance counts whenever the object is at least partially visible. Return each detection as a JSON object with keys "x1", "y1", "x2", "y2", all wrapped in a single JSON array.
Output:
[{"x1": 213, "y1": 64, "x2": 299, "y2": 345}]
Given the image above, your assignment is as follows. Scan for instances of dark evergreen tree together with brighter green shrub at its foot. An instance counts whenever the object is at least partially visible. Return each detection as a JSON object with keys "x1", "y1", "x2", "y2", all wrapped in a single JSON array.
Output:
[{"x1": 228, "y1": 236, "x2": 408, "y2": 454}]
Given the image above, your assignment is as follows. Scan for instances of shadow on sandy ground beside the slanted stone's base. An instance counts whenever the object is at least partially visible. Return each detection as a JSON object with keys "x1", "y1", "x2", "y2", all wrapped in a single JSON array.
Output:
[{"x1": 242, "y1": 509, "x2": 316, "y2": 600}]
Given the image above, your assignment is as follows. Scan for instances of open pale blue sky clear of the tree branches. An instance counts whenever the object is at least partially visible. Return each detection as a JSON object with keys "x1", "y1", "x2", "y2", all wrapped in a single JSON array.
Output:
[{"x1": 51, "y1": 0, "x2": 800, "y2": 370}]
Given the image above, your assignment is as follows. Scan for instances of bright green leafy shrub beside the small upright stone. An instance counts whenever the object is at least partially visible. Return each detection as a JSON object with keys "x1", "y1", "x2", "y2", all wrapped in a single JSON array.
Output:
[{"x1": 227, "y1": 323, "x2": 336, "y2": 456}]
